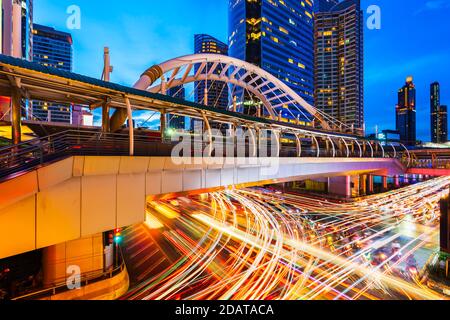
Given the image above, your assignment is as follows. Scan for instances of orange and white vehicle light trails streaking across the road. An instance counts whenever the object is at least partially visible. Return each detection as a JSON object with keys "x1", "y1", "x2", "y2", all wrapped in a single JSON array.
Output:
[{"x1": 121, "y1": 177, "x2": 450, "y2": 300}]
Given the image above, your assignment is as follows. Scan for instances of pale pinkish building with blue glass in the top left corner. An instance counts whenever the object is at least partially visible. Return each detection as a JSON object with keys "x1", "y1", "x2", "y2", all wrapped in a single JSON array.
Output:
[{"x1": 0, "y1": 0, "x2": 33, "y2": 60}]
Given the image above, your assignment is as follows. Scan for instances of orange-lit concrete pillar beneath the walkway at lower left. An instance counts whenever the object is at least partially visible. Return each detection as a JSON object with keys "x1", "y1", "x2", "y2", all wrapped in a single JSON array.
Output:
[{"x1": 42, "y1": 233, "x2": 105, "y2": 286}]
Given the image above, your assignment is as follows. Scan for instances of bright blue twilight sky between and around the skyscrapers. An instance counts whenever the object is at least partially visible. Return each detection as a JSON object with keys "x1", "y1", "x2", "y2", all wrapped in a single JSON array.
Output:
[{"x1": 34, "y1": 0, "x2": 450, "y2": 141}]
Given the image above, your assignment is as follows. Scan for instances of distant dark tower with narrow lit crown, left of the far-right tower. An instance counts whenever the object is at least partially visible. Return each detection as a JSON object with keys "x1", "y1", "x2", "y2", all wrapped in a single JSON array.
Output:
[{"x1": 396, "y1": 77, "x2": 417, "y2": 145}]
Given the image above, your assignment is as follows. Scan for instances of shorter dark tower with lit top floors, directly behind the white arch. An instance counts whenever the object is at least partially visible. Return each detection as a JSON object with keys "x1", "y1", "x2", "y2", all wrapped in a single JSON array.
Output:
[{"x1": 194, "y1": 34, "x2": 228, "y2": 109}]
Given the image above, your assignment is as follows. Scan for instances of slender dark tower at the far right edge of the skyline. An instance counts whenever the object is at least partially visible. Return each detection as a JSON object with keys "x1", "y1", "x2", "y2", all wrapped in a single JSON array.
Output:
[{"x1": 430, "y1": 82, "x2": 448, "y2": 143}]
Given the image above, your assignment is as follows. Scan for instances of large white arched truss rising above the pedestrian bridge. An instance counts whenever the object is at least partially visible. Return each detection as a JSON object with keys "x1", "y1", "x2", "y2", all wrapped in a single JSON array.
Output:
[{"x1": 135, "y1": 54, "x2": 352, "y2": 132}]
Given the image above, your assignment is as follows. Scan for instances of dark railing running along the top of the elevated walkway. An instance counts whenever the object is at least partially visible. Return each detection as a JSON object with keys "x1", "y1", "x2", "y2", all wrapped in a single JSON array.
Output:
[{"x1": 0, "y1": 130, "x2": 410, "y2": 181}]
